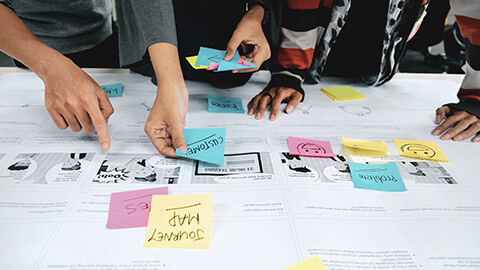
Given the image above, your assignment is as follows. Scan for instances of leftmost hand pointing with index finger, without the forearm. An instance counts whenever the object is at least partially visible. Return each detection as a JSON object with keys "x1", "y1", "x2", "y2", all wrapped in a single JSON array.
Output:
[{"x1": 42, "y1": 56, "x2": 113, "y2": 151}]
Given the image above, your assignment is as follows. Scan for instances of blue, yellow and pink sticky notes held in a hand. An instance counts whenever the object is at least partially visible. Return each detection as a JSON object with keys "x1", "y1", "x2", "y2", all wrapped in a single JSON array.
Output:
[{"x1": 186, "y1": 47, "x2": 257, "y2": 72}]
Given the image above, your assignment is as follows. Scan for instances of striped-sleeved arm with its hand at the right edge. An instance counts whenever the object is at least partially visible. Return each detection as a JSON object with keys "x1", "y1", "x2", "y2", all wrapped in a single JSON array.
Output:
[{"x1": 432, "y1": 0, "x2": 480, "y2": 142}]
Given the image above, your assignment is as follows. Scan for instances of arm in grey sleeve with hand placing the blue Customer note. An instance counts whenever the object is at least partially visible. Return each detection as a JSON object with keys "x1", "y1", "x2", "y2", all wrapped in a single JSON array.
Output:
[{"x1": 116, "y1": 0, "x2": 188, "y2": 157}]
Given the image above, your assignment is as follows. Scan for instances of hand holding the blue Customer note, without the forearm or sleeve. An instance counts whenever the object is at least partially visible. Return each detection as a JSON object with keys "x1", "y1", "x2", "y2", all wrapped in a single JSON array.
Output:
[{"x1": 145, "y1": 84, "x2": 188, "y2": 157}]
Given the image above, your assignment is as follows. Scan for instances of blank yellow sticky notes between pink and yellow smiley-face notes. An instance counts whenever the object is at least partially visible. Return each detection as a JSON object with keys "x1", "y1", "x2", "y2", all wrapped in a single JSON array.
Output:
[{"x1": 342, "y1": 138, "x2": 391, "y2": 157}]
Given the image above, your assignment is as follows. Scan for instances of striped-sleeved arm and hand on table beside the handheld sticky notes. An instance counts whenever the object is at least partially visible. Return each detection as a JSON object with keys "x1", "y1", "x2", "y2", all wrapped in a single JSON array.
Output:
[{"x1": 248, "y1": 0, "x2": 331, "y2": 121}]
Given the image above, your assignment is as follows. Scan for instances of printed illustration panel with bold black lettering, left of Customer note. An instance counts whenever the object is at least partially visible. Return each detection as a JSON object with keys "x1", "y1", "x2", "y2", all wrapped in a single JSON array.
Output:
[{"x1": 93, "y1": 153, "x2": 181, "y2": 184}]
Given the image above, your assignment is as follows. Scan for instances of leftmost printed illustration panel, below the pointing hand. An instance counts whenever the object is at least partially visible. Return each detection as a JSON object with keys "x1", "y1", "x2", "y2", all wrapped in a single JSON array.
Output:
[{"x1": 0, "y1": 153, "x2": 95, "y2": 184}]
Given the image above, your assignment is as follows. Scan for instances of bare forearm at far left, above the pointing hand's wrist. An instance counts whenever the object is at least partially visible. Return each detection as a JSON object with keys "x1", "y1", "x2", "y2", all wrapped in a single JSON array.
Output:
[{"x1": 0, "y1": 4, "x2": 64, "y2": 79}]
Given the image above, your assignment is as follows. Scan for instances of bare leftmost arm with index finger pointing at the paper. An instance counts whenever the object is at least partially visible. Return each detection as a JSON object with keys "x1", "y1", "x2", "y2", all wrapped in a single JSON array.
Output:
[{"x1": 0, "y1": 4, "x2": 113, "y2": 151}]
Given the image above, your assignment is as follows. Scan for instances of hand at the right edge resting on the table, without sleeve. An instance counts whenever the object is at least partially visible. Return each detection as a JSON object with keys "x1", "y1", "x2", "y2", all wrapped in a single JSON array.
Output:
[{"x1": 432, "y1": 106, "x2": 480, "y2": 142}]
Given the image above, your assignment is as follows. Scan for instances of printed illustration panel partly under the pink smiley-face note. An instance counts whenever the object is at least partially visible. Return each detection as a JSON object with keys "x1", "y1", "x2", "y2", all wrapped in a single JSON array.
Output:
[{"x1": 280, "y1": 152, "x2": 352, "y2": 183}]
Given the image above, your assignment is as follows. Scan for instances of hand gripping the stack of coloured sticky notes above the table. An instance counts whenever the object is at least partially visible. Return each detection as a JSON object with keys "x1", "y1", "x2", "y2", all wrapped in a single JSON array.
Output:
[{"x1": 224, "y1": 5, "x2": 271, "y2": 73}]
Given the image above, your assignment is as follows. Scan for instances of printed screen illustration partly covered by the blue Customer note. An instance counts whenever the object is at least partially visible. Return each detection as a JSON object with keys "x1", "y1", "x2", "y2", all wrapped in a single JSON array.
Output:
[{"x1": 191, "y1": 152, "x2": 275, "y2": 184}]
